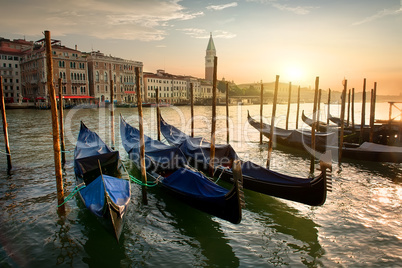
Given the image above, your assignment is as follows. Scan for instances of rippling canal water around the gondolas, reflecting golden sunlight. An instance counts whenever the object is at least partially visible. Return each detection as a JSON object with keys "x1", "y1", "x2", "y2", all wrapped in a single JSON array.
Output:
[{"x1": 0, "y1": 103, "x2": 402, "y2": 267}]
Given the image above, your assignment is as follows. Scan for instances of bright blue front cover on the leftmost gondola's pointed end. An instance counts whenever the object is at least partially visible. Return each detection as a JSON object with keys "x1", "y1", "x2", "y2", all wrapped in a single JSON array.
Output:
[{"x1": 80, "y1": 175, "x2": 130, "y2": 217}]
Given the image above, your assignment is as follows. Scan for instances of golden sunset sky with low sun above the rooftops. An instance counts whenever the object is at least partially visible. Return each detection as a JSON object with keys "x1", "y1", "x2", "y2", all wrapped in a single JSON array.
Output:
[{"x1": 0, "y1": 0, "x2": 402, "y2": 95}]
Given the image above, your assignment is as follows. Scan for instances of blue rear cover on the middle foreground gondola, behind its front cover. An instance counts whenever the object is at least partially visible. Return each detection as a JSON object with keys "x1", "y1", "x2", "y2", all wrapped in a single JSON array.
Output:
[{"x1": 120, "y1": 118, "x2": 187, "y2": 170}]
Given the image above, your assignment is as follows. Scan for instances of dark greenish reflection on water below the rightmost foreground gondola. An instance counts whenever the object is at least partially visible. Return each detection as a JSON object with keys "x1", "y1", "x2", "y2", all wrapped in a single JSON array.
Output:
[{"x1": 239, "y1": 191, "x2": 325, "y2": 267}]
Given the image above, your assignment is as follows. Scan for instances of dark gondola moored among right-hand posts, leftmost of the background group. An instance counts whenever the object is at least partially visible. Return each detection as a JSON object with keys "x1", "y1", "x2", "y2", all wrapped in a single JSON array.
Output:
[{"x1": 247, "y1": 113, "x2": 337, "y2": 153}]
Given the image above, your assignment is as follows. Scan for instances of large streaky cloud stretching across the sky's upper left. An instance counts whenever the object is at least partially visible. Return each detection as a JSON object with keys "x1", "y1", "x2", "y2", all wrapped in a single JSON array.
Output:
[{"x1": 0, "y1": 0, "x2": 204, "y2": 41}]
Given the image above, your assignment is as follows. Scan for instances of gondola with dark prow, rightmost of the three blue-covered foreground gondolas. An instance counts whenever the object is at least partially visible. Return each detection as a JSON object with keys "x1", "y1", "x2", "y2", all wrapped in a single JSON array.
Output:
[{"x1": 161, "y1": 114, "x2": 332, "y2": 206}]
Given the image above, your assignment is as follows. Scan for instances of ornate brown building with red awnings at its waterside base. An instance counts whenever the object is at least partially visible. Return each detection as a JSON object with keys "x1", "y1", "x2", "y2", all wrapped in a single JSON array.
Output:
[{"x1": 21, "y1": 39, "x2": 93, "y2": 107}]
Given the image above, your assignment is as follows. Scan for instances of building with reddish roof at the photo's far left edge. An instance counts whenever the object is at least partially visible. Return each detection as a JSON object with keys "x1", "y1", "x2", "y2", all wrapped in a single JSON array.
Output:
[{"x1": 0, "y1": 38, "x2": 33, "y2": 103}]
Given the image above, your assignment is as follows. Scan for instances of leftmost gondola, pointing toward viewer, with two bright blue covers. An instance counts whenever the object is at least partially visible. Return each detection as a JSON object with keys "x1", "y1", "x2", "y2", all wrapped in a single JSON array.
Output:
[{"x1": 74, "y1": 122, "x2": 131, "y2": 241}]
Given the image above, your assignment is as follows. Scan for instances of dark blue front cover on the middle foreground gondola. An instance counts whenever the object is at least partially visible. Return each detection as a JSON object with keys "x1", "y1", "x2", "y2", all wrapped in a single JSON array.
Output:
[{"x1": 162, "y1": 168, "x2": 229, "y2": 202}]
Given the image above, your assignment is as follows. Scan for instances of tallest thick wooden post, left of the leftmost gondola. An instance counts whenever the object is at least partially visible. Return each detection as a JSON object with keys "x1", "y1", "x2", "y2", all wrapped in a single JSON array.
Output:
[{"x1": 45, "y1": 31, "x2": 65, "y2": 211}]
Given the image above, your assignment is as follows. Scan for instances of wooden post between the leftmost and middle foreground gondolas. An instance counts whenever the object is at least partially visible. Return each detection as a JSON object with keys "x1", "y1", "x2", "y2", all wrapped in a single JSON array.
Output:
[{"x1": 135, "y1": 67, "x2": 148, "y2": 204}]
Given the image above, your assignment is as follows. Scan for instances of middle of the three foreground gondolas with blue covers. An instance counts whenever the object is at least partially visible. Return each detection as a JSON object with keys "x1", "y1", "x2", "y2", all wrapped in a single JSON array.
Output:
[{"x1": 120, "y1": 117, "x2": 244, "y2": 224}]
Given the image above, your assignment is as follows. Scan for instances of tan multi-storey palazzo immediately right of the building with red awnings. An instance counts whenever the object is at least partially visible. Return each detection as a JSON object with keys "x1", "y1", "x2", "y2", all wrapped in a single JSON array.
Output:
[{"x1": 87, "y1": 51, "x2": 144, "y2": 103}]
